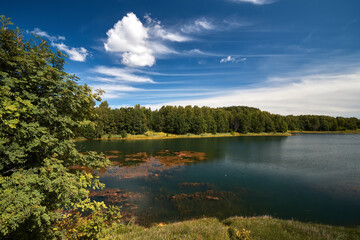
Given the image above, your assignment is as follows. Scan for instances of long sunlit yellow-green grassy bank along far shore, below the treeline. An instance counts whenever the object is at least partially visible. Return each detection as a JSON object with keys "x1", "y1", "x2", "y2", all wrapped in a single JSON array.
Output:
[{"x1": 74, "y1": 131, "x2": 292, "y2": 140}]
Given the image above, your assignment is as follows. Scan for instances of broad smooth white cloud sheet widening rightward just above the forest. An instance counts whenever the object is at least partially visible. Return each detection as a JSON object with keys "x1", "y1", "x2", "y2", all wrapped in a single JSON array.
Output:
[{"x1": 146, "y1": 72, "x2": 360, "y2": 117}]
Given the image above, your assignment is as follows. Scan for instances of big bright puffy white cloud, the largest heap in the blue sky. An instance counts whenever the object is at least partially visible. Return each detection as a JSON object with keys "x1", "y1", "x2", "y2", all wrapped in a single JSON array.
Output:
[{"x1": 104, "y1": 13, "x2": 190, "y2": 67}]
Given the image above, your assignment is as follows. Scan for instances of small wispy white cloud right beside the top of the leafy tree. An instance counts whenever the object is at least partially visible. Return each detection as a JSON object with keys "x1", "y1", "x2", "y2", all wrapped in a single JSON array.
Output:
[{"x1": 32, "y1": 28, "x2": 89, "y2": 62}]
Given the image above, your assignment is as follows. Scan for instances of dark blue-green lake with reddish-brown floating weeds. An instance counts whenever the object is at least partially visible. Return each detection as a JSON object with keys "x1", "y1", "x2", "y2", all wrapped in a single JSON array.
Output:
[{"x1": 76, "y1": 134, "x2": 360, "y2": 226}]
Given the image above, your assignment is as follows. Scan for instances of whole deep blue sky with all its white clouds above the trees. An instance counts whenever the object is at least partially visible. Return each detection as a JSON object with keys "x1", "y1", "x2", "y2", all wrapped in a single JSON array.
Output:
[{"x1": 0, "y1": 0, "x2": 360, "y2": 117}]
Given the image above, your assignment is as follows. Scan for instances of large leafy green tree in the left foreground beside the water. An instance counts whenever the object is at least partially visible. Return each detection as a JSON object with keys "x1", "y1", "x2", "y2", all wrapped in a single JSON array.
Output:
[{"x1": 0, "y1": 16, "x2": 115, "y2": 239}]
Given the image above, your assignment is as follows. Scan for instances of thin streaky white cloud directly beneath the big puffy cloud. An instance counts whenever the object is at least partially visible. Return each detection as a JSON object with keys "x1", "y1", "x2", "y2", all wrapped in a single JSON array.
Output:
[{"x1": 93, "y1": 66, "x2": 154, "y2": 83}]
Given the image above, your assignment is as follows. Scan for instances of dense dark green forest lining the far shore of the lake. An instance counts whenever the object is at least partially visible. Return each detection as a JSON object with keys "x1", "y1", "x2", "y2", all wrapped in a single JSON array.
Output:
[{"x1": 82, "y1": 101, "x2": 360, "y2": 138}]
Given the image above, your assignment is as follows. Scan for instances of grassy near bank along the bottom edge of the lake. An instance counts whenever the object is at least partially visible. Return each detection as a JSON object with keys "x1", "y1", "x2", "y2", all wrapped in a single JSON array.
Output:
[{"x1": 104, "y1": 217, "x2": 360, "y2": 240}]
